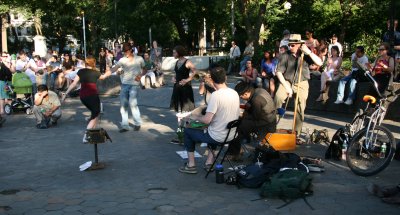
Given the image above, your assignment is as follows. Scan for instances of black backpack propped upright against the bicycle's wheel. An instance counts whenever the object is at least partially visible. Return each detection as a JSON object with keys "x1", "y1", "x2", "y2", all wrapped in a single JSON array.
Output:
[{"x1": 325, "y1": 127, "x2": 350, "y2": 160}]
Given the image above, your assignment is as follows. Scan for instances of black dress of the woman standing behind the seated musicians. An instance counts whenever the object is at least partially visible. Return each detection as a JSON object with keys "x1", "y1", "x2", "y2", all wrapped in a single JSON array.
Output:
[{"x1": 170, "y1": 60, "x2": 194, "y2": 112}]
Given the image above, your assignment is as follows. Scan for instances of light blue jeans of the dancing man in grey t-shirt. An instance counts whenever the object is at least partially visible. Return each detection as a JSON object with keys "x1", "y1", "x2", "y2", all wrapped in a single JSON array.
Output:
[{"x1": 119, "y1": 84, "x2": 142, "y2": 128}]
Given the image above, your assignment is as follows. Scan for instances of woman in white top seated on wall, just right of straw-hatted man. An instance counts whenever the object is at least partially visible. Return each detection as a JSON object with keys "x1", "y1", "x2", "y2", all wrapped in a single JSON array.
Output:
[{"x1": 316, "y1": 46, "x2": 342, "y2": 102}]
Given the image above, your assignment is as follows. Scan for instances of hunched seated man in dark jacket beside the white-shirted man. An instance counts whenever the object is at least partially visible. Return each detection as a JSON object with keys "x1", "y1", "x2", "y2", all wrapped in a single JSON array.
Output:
[{"x1": 231, "y1": 81, "x2": 276, "y2": 155}]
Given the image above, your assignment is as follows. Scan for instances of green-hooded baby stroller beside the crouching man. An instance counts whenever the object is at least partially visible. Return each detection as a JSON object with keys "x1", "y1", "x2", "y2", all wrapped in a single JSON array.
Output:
[{"x1": 4, "y1": 71, "x2": 33, "y2": 115}]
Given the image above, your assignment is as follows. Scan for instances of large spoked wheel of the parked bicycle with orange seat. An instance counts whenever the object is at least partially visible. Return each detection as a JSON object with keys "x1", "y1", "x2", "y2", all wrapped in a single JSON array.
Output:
[{"x1": 346, "y1": 125, "x2": 396, "y2": 176}]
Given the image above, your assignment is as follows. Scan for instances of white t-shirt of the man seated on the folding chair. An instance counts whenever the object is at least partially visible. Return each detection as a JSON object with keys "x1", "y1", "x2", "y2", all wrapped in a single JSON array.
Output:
[{"x1": 206, "y1": 88, "x2": 240, "y2": 142}]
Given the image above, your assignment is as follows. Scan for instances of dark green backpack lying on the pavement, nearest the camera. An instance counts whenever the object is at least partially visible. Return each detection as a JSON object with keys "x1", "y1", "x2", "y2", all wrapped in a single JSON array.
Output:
[{"x1": 260, "y1": 169, "x2": 313, "y2": 209}]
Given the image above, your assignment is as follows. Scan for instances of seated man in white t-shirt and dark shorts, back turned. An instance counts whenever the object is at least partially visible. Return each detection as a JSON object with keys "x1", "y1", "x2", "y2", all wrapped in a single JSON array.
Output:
[{"x1": 179, "y1": 67, "x2": 240, "y2": 174}]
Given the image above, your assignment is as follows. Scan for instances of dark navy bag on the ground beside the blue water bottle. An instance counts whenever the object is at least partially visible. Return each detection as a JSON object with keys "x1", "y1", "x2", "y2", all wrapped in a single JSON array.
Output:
[{"x1": 236, "y1": 164, "x2": 273, "y2": 188}]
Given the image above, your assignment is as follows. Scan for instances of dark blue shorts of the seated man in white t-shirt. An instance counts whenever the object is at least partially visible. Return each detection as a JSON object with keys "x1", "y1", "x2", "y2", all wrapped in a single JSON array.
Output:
[{"x1": 183, "y1": 128, "x2": 220, "y2": 152}]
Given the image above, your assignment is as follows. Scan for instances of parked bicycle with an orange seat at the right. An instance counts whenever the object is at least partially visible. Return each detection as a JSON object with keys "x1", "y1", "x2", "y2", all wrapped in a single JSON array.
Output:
[{"x1": 346, "y1": 70, "x2": 398, "y2": 176}]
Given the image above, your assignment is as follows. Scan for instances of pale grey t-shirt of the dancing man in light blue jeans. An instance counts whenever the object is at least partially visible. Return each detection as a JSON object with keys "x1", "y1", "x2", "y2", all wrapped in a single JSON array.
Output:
[{"x1": 116, "y1": 55, "x2": 144, "y2": 85}]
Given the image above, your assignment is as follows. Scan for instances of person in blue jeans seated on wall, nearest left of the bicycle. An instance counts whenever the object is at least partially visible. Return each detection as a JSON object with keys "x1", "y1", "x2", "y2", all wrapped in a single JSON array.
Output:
[{"x1": 335, "y1": 46, "x2": 368, "y2": 105}]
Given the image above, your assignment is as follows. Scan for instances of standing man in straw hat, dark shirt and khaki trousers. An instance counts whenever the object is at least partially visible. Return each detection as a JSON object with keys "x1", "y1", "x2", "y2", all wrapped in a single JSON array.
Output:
[{"x1": 275, "y1": 34, "x2": 322, "y2": 143}]
